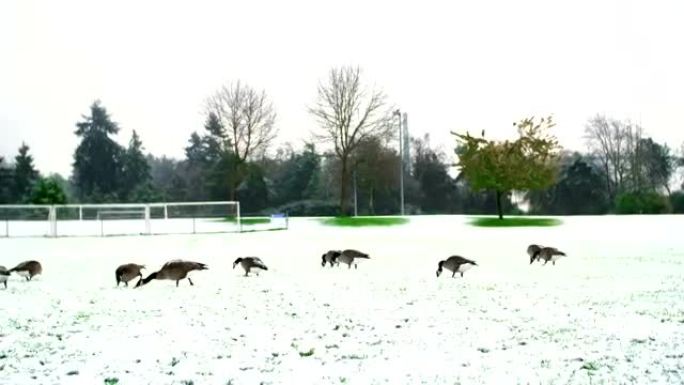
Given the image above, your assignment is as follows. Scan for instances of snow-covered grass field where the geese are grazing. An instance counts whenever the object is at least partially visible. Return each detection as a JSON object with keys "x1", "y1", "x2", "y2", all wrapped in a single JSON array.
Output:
[{"x1": 0, "y1": 216, "x2": 684, "y2": 385}]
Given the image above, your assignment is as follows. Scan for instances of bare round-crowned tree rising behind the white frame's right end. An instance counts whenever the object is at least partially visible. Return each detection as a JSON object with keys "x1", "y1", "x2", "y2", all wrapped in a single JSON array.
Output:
[{"x1": 205, "y1": 81, "x2": 277, "y2": 199}]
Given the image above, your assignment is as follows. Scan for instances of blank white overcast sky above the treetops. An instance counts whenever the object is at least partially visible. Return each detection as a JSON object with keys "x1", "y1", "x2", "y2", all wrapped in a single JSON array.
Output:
[{"x1": 0, "y1": 0, "x2": 684, "y2": 176}]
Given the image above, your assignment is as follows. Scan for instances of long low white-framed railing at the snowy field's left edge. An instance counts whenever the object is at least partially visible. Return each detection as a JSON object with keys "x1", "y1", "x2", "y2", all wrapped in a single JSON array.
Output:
[{"x1": 0, "y1": 201, "x2": 242, "y2": 237}]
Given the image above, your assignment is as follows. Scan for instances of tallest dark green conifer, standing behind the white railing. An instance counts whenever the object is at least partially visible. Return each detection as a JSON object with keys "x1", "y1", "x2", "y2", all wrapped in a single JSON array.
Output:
[{"x1": 73, "y1": 101, "x2": 124, "y2": 201}]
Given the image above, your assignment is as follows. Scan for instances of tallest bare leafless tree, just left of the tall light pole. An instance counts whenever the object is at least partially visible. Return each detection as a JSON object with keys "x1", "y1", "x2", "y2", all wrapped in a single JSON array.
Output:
[{"x1": 309, "y1": 67, "x2": 391, "y2": 215}]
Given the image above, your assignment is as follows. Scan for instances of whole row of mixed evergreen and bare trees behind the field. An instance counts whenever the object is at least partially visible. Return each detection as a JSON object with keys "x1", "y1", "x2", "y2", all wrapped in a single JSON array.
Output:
[{"x1": 0, "y1": 67, "x2": 684, "y2": 215}]
